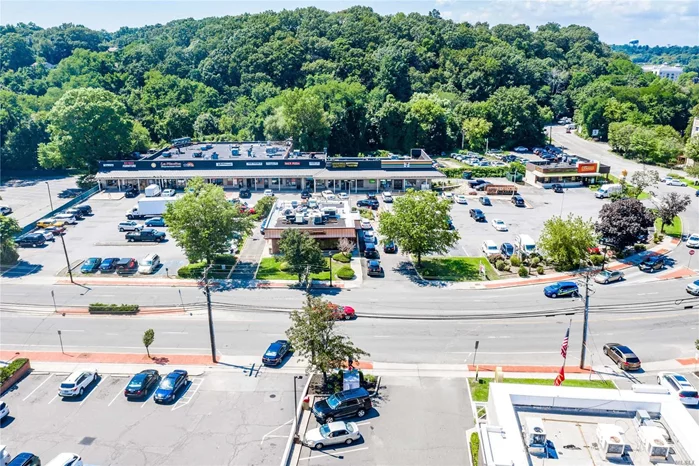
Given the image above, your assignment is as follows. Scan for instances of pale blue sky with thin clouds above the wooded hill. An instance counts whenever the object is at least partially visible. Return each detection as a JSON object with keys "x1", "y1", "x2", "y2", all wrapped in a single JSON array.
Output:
[{"x1": 0, "y1": 0, "x2": 699, "y2": 45}]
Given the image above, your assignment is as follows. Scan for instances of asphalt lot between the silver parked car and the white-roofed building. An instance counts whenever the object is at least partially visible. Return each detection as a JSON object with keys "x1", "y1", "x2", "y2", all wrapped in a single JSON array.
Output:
[{"x1": 298, "y1": 377, "x2": 473, "y2": 466}]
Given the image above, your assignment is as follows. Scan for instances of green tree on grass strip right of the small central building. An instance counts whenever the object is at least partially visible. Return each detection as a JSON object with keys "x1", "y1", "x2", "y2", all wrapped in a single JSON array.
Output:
[{"x1": 379, "y1": 190, "x2": 459, "y2": 267}]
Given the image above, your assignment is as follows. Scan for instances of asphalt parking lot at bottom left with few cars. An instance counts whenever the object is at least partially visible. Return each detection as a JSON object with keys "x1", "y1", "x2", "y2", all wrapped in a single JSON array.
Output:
[{"x1": 0, "y1": 368, "x2": 294, "y2": 466}]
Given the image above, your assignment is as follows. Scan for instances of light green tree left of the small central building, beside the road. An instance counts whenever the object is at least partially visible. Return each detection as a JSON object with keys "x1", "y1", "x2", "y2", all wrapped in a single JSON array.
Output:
[{"x1": 163, "y1": 178, "x2": 252, "y2": 264}]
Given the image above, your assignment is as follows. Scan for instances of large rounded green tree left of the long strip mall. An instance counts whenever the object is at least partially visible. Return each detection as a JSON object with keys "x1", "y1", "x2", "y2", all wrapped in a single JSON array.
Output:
[{"x1": 39, "y1": 89, "x2": 133, "y2": 171}]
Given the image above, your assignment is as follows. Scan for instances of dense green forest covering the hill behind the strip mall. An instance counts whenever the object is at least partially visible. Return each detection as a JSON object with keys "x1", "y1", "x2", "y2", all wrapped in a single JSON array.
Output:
[{"x1": 0, "y1": 7, "x2": 699, "y2": 171}]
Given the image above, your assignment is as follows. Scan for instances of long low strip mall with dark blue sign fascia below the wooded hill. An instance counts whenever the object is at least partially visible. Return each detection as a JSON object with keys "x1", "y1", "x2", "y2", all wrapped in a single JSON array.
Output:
[{"x1": 96, "y1": 142, "x2": 445, "y2": 193}]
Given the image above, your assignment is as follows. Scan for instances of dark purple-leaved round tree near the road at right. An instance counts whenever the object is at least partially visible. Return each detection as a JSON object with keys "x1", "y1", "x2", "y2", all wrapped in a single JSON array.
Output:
[{"x1": 595, "y1": 199, "x2": 654, "y2": 250}]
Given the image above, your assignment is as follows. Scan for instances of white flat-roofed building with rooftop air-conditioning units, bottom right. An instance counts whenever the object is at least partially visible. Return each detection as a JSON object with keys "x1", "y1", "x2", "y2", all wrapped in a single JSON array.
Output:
[{"x1": 478, "y1": 383, "x2": 699, "y2": 466}]
